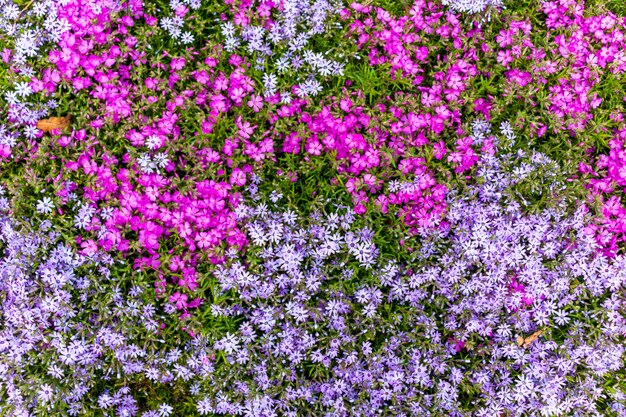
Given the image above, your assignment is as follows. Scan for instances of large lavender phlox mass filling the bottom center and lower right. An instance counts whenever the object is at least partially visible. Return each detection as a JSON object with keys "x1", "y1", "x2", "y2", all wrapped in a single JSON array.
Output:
[{"x1": 199, "y1": 122, "x2": 626, "y2": 416}]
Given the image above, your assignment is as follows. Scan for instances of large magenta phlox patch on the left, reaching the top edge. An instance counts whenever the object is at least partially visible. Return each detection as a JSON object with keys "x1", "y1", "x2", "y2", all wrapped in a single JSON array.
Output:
[{"x1": 22, "y1": 1, "x2": 255, "y2": 311}]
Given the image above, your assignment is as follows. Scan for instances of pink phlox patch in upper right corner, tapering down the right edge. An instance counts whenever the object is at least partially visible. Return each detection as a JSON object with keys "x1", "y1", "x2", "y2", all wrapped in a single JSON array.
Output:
[{"x1": 438, "y1": 0, "x2": 626, "y2": 256}]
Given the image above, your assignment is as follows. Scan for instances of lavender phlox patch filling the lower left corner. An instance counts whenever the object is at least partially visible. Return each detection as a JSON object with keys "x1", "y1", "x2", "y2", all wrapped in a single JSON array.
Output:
[{"x1": 0, "y1": 187, "x2": 218, "y2": 417}]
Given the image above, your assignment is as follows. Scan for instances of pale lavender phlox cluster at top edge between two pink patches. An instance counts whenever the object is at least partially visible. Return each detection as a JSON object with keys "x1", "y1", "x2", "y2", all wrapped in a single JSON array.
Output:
[{"x1": 221, "y1": 0, "x2": 344, "y2": 96}]
